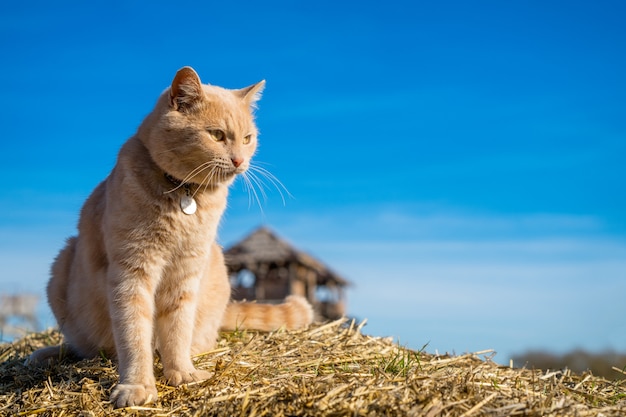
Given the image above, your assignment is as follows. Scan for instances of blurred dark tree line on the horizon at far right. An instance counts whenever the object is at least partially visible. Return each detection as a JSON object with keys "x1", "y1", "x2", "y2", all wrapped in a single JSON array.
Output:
[{"x1": 513, "y1": 349, "x2": 626, "y2": 381}]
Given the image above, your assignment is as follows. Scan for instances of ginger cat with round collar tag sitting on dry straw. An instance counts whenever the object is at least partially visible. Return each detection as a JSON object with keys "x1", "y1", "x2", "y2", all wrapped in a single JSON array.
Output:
[{"x1": 30, "y1": 67, "x2": 313, "y2": 407}]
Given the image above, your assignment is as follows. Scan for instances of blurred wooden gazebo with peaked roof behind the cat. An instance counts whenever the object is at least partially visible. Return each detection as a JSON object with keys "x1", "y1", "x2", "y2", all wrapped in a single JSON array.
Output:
[{"x1": 224, "y1": 227, "x2": 350, "y2": 319}]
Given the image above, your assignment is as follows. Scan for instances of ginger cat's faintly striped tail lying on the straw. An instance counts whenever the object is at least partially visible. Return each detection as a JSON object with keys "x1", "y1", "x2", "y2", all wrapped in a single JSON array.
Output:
[{"x1": 221, "y1": 295, "x2": 313, "y2": 332}]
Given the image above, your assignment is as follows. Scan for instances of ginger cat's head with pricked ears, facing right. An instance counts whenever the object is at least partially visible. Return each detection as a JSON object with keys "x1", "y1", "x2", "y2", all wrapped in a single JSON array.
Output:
[{"x1": 144, "y1": 67, "x2": 265, "y2": 186}]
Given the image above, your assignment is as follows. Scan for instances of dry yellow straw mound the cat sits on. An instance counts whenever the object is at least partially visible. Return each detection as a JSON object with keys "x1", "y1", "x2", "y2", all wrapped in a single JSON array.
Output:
[{"x1": 0, "y1": 321, "x2": 626, "y2": 417}]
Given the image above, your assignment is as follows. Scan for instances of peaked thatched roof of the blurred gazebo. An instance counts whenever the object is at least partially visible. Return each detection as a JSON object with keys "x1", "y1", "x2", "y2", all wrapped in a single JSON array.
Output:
[{"x1": 224, "y1": 227, "x2": 350, "y2": 287}]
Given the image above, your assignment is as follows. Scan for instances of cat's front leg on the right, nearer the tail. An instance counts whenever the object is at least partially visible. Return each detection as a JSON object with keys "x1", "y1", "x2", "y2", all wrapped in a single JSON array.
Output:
[{"x1": 156, "y1": 273, "x2": 211, "y2": 386}]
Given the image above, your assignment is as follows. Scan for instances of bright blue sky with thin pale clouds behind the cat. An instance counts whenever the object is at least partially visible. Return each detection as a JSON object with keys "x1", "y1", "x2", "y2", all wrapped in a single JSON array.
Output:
[{"x1": 0, "y1": 1, "x2": 626, "y2": 362}]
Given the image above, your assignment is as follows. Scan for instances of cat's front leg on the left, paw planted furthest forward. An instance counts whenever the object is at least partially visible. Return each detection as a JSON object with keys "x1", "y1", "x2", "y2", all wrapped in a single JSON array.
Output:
[{"x1": 108, "y1": 266, "x2": 157, "y2": 408}]
